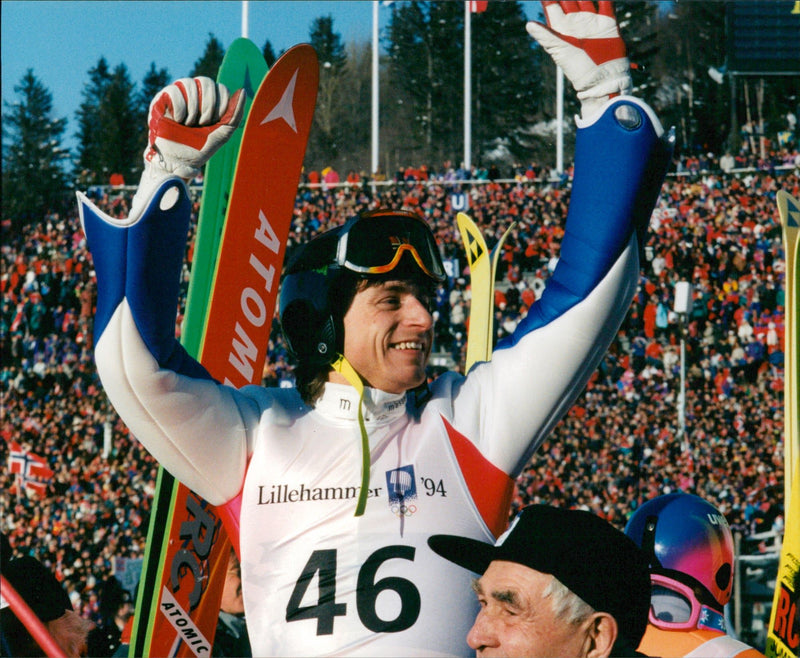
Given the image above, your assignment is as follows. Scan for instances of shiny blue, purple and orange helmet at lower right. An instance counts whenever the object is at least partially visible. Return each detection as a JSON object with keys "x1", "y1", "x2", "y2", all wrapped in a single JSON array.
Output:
[{"x1": 625, "y1": 493, "x2": 733, "y2": 611}]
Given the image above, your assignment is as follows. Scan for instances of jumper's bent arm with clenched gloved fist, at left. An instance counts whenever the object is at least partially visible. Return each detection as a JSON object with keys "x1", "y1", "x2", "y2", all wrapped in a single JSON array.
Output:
[{"x1": 78, "y1": 78, "x2": 252, "y2": 503}]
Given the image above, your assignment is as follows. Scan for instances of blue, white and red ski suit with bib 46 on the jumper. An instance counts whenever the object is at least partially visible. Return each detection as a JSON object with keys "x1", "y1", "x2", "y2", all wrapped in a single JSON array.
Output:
[{"x1": 80, "y1": 97, "x2": 669, "y2": 656}]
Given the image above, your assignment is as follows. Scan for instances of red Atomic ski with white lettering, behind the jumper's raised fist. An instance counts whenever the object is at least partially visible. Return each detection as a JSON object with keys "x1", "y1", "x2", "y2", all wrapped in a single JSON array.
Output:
[{"x1": 138, "y1": 45, "x2": 319, "y2": 658}]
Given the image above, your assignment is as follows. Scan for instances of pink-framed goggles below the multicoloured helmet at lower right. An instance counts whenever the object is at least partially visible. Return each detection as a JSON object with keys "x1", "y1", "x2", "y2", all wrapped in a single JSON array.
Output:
[{"x1": 650, "y1": 573, "x2": 725, "y2": 632}]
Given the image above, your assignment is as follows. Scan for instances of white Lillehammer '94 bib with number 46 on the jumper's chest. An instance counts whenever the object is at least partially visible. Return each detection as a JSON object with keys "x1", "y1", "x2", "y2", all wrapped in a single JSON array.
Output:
[{"x1": 241, "y1": 384, "x2": 494, "y2": 656}]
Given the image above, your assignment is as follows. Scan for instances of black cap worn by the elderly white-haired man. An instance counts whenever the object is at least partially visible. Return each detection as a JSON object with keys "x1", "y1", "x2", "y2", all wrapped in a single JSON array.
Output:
[{"x1": 428, "y1": 505, "x2": 650, "y2": 655}]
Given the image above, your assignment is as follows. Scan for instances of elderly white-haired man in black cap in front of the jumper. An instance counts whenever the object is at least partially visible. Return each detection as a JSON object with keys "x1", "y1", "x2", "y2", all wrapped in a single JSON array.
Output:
[{"x1": 428, "y1": 505, "x2": 650, "y2": 658}]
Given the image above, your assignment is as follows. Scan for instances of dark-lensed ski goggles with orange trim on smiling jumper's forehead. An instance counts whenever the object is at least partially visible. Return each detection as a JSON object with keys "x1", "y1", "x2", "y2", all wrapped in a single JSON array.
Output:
[{"x1": 336, "y1": 211, "x2": 446, "y2": 282}]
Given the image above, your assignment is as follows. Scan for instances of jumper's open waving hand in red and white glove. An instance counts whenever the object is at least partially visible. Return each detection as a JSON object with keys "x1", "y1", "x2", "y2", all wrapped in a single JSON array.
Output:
[{"x1": 526, "y1": 0, "x2": 632, "y2": 119}]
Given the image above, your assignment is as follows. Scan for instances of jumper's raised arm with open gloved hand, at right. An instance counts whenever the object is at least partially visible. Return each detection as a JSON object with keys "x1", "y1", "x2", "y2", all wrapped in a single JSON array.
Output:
[{"x1": 456, "y1": 2, "x2": 672, "y2": 475}]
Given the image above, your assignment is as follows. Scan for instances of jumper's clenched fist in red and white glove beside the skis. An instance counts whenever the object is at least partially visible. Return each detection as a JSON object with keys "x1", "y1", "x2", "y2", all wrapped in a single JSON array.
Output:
[{"x1": 144, "y1": 77, "x2": 245, "y2": 179}]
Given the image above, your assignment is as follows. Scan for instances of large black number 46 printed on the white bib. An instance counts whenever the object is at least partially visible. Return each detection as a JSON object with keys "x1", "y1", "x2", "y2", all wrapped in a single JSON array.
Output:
[{"x1": 286, "y1": 546, "x2": 421, "y2": 635}]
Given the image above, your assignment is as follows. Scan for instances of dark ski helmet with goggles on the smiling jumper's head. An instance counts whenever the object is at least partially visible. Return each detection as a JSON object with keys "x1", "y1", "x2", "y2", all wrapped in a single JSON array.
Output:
[{"x1": 279, "y1": 209, "x2": 445, "y2": 366}]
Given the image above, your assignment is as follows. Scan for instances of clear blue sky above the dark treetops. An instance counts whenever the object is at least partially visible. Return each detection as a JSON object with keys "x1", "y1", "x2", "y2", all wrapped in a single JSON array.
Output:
[{"x1": 0, "y1": 0, "x2": 539, "y2": 149}]
